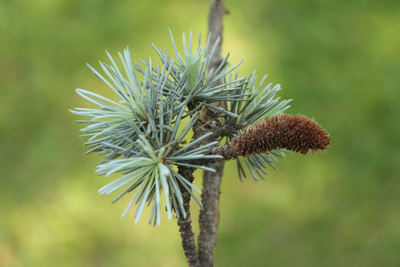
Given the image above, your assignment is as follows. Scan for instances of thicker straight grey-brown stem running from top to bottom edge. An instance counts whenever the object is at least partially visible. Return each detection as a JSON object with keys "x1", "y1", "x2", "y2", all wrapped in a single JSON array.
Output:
[{"x1": 198, "y1": 0, "x2": 227, "y2": 267}]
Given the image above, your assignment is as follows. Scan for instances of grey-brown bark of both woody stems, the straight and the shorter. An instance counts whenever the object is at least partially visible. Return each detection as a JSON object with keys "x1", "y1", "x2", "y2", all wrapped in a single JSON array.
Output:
[{"x1": 178, "y1": 0, "x2": 227, "y2": 267}]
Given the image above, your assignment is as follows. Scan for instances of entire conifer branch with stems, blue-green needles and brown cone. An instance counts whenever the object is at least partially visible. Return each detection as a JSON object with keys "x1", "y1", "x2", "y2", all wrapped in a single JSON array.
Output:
[{"x1": 71, "y1": 0, "x2": 330, "y2": 266}]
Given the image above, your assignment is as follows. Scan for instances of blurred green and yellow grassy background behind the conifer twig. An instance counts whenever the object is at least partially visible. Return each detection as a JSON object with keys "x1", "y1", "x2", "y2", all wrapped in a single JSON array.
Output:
[{"x1": 0, "y1": 0, "x2": 400, "y2": 266}]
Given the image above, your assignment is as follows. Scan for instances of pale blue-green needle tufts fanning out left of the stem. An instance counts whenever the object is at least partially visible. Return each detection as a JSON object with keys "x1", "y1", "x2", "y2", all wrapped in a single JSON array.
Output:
[{"x1": 71, "y1": 34, "x2": 223, "y2": 224}]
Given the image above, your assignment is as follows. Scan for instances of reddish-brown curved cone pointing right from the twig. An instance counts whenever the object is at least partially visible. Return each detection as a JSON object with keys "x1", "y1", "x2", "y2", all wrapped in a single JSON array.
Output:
[{"x1": 215, "y1": 115, "x2": 330, "y2": 159}]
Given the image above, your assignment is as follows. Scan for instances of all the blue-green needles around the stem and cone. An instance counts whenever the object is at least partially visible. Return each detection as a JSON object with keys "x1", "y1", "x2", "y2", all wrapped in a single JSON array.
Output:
[{"x1": 71, "y1": 32, "x2": 288, "y2": 225}]
